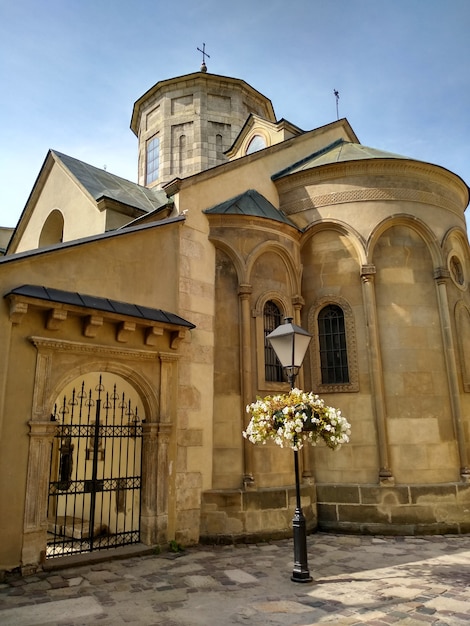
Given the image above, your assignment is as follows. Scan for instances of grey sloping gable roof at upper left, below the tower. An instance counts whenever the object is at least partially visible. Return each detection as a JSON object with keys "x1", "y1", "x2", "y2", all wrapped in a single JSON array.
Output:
[{"x1": 51, "y1": 150, "x2": 168, "y2": 213}]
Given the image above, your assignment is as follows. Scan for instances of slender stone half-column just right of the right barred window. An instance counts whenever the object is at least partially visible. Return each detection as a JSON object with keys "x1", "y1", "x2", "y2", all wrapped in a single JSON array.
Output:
[{"x1": 361, "y1": 265, "x2": 395, "y2": 486}]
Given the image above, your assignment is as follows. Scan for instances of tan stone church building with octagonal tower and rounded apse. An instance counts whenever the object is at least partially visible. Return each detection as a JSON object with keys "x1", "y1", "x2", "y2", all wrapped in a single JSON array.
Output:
[{"x1": 0, "y1": 65, "x2": 470, "y2": 572}]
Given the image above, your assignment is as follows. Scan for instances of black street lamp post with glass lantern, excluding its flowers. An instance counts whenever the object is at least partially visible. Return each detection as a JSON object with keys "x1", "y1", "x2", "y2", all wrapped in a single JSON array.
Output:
[{"x1": 267, "y1": 317, "x2": 312, "y2": 583}]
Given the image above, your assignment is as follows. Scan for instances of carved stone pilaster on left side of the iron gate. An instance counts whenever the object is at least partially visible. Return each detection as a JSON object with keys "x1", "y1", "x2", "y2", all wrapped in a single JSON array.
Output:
[{"x1": 21, "y1": 421, "x2": 57, "y2": 575}]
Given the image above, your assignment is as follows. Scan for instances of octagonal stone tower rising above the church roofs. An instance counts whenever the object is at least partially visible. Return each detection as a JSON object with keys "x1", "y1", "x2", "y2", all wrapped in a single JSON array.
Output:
[{"x1": 131, "y1": 64, "x2": 276, "y2": 187}]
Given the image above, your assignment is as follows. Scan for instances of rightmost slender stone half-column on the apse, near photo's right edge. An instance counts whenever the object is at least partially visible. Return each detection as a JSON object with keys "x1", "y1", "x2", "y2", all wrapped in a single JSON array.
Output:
[{"x1": 434, "y1": 268, "x2": 470, "y2": 482}]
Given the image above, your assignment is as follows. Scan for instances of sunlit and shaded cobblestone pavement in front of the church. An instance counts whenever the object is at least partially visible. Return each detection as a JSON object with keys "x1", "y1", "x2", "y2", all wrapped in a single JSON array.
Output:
[{"x1": 0, "y1": 533, "x2": 470, "y2": 626}]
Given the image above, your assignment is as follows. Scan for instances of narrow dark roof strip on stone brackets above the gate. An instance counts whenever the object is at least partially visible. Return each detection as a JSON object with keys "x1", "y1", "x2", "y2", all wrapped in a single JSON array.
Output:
[{"x1": 5, "y1": 285, "x2": 196, "y2": 328}]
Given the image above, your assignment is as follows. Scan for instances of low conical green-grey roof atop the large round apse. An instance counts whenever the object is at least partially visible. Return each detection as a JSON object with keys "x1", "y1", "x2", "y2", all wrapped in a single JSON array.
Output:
[{"x1": 272, "y1": 139, "x2": 409, "y2": 180}]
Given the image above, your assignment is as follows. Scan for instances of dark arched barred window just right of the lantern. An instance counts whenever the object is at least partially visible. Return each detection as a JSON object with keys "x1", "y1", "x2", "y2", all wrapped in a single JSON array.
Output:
[{"x1": 318, "y1": 304, "x2": 349, "y2": 385}]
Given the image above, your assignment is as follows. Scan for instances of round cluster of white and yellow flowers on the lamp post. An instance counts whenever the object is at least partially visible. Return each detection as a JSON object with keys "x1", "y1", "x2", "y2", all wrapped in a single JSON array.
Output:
[{"x1": 243, "y1": 388, "x2": 351, "y2": 451}]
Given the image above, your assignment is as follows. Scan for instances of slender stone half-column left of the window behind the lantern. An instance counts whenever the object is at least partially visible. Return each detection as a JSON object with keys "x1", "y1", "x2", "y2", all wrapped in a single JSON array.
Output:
[{"x1": 238, "y1": 285, "x2": 255, "y2": 488}]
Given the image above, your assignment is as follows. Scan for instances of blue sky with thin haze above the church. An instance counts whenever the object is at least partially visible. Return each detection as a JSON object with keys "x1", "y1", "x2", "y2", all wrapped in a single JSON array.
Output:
[{"x1": 0, "y1": 0, "x2": 470, "y2": 226}]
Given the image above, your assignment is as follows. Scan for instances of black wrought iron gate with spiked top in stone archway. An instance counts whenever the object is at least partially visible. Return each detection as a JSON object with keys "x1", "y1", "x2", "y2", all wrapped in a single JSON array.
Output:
[{"x1": 47, "y1": 376, "x2": 142, "y2": 558}]
